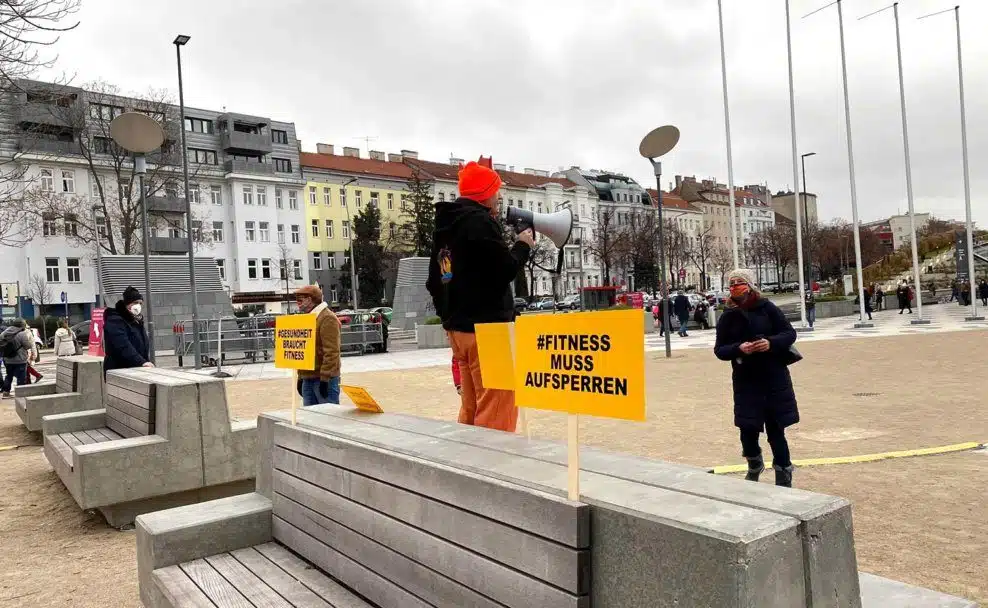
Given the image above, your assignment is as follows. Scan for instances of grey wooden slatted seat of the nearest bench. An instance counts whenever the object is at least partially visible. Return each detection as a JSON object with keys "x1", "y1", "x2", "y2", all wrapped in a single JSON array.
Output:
[{"x1": 152, "y1": 543, "x2": 373, "y2": 608}]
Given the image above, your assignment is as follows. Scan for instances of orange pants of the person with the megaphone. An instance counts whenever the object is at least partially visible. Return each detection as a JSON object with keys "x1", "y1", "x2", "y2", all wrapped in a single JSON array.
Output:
[{"x1": 446, "y1": 331, "x2": 518, "y2": 433}]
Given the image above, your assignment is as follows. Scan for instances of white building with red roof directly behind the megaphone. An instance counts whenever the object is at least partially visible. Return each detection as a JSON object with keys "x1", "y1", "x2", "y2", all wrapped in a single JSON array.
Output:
[{"x1": 403, "y1": 157, "x2": 601, "y2": 297}]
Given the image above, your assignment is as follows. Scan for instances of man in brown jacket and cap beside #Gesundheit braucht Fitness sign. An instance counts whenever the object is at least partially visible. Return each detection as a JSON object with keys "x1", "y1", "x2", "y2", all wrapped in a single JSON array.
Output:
[{"x1": 295, "y1": 285, "x2": 340, "y2": 406}]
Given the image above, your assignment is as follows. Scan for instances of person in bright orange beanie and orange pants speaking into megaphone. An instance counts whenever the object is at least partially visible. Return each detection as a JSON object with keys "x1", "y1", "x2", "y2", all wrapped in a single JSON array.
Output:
[{"x1": 426, "y1": 157, "x2": 535, "y2": 432}]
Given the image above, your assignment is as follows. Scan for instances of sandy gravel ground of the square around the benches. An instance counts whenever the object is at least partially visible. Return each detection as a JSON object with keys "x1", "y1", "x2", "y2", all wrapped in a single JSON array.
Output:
[{"x1": 0, "y1": 332, "x2": 988, "y2": 607}]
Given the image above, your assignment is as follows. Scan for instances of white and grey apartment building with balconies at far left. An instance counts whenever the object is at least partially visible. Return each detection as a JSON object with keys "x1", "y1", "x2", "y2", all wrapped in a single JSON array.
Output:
[{"x1": 0, "y1": 81, "x2": 307, "y2": 320}]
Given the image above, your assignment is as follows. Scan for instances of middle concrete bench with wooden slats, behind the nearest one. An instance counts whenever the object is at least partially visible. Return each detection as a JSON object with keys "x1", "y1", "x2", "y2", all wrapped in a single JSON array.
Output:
[{"x1": 42, "y1": 368, "x2": 257, "y2": 527}]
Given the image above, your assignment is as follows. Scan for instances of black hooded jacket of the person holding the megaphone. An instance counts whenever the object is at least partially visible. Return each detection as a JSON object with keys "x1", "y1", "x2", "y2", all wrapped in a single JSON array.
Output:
[{"x1": 426, "y1": 198, "x2": 530, "y2": 333}]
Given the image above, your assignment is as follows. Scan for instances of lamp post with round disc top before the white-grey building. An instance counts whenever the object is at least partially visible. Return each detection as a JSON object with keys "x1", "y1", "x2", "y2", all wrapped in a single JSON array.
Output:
[{"x1": 110, "y1": 112, "x2": 165, "y2": 363}]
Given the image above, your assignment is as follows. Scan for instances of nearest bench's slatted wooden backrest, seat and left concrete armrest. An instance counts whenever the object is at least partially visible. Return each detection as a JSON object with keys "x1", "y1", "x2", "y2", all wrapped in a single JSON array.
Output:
[{"x1": 137, "y1": 412, "x2": 591, "y2": 608}]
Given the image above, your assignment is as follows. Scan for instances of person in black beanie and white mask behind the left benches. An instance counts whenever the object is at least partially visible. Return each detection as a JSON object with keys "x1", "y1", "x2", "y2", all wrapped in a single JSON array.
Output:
[{"x1": 103, "y1": 286, "x2": 154, "y2": 373}]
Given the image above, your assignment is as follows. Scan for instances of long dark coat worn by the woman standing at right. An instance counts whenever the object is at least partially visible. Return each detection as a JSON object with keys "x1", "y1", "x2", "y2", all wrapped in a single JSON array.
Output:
[{"x1": 714, "y1": 298, "x2": 799, "y2": 429}]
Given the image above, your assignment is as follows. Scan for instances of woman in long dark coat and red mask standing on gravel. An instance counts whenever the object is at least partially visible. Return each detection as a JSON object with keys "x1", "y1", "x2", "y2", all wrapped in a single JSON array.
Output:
[{"x1": 714, "y1": 269, "x2": 799, "y2": 487}]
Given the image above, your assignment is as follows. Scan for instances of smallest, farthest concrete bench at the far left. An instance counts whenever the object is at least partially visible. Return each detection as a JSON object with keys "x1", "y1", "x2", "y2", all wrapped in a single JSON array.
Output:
[{"x1": 14, "y1": 355, "x2": 103, "y2": 431}]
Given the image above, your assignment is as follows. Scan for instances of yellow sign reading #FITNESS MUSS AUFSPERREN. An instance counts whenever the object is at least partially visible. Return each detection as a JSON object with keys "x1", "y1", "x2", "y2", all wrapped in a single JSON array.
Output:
[{"x1": 515, "y1": 309, "x2": 645, "y2": 421}]
